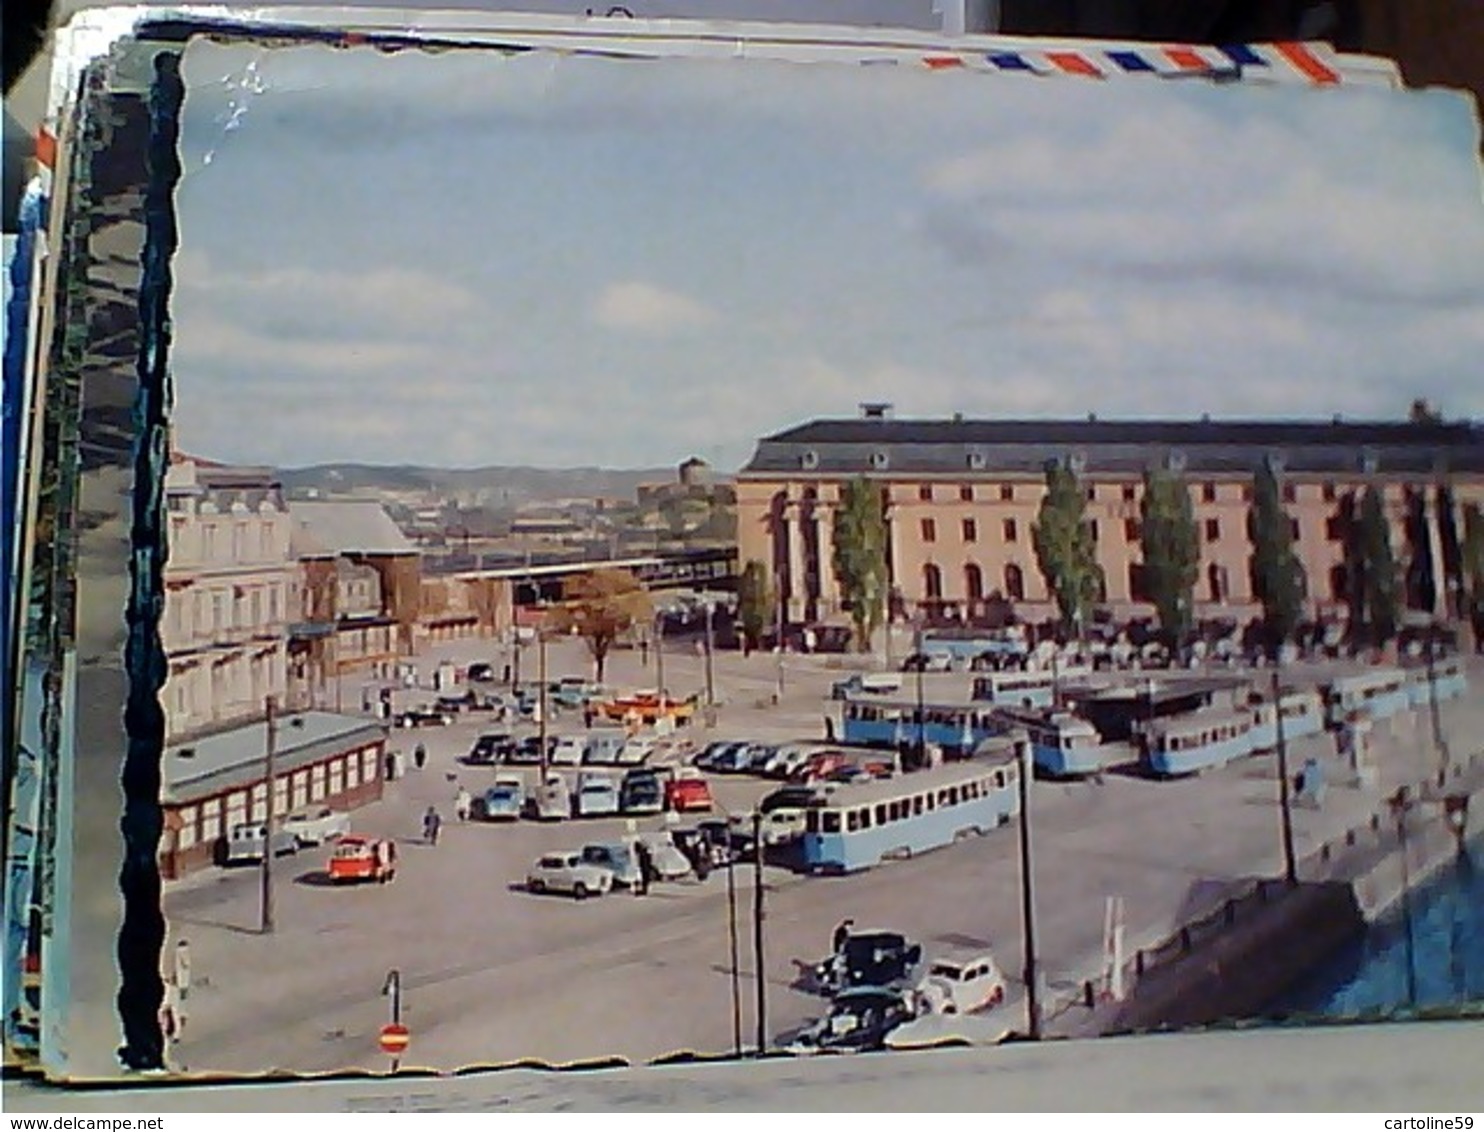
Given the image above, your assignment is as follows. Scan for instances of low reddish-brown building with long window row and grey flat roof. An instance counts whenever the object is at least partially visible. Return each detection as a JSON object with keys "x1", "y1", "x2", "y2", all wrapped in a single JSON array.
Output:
[{"x1": 159, "y1": 712, "x2": 386, "y2": 880}]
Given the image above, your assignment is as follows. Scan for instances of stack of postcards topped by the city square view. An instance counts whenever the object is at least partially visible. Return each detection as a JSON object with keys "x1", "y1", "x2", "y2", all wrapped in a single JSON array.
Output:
[{"x1": 6, "y1": 11, "x2": 1484, "y2": 1097}]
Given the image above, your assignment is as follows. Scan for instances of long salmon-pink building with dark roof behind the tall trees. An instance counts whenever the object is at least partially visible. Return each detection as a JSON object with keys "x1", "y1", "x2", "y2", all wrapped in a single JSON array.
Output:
[{"x1": 738, "y1": 405, "x2": 1484, "y2": 622}]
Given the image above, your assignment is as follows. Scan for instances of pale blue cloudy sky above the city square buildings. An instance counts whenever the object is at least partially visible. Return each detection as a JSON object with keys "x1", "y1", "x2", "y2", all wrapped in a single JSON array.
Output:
[{"x1": 174, "y1": 45, "x2": 1484, "y2": 469}]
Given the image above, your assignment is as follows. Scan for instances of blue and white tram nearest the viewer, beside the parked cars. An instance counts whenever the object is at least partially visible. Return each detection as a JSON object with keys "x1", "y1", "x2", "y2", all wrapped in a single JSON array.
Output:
[{"x1": 803, "y1": 749, "x2": 1020, "y2": 872}]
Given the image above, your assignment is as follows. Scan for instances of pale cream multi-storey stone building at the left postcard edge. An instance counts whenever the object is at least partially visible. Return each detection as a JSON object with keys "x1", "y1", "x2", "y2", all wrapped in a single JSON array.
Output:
[{"x1": 160, "y1": 454, "x2": 297, "y2": 743}]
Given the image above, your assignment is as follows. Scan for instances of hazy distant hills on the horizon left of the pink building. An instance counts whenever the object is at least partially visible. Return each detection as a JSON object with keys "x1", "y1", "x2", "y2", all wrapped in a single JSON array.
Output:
[{"x1": 278, "y1": 464, "x2": 675, "y2": 507}]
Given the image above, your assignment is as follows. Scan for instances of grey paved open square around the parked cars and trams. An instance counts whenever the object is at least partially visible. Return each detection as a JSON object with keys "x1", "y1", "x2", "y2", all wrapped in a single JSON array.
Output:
[{"x1": 136, "y1": 645, "x2": 1480, "y2": 1073}]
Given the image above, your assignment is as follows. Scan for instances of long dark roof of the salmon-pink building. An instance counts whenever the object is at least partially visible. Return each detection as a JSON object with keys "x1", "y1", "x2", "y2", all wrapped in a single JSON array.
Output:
[{"x1": 742, "y1": 418, "x2": 1484, "y2": 476}]
